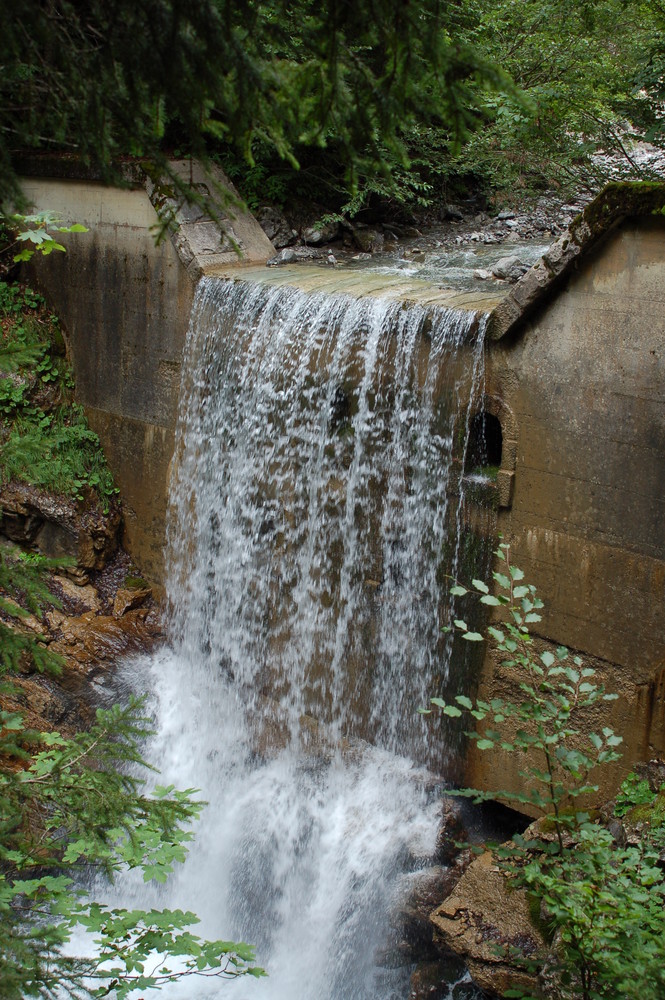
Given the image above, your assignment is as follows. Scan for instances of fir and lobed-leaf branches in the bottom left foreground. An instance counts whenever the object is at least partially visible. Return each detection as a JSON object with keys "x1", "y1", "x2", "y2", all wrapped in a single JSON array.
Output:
[{"x1": 0, "y1": 684, "x2": 263, "y2": 1000}]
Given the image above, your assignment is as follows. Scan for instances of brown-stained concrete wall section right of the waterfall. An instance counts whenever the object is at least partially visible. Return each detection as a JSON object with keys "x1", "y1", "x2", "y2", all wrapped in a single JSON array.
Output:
[{"x1": 466, "y1": 219, "x2": 665, "y2": 804}]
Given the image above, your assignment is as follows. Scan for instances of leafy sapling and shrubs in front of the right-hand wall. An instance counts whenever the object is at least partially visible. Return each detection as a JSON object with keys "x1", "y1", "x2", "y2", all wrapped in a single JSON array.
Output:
[{"x1": 432, "y1": 544, "x2": 665, "y2": 1000}]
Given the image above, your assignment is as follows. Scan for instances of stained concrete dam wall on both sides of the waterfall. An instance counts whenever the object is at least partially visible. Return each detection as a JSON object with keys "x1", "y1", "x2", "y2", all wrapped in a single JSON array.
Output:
[{"x1": 20, "y1": 168, "x2": 665, "y2": 789}]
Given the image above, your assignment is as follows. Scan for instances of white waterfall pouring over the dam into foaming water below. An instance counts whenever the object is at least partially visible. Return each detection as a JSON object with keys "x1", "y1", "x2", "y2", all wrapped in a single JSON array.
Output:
[{"x1": 120, "y1": 278, "x2": 492, "y2": 1000}]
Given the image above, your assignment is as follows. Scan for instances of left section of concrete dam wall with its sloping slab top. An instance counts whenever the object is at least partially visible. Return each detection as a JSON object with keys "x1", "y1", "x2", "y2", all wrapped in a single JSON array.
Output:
[{"x1": 22, "y1": 157, "x2": 274, "y2": 582}]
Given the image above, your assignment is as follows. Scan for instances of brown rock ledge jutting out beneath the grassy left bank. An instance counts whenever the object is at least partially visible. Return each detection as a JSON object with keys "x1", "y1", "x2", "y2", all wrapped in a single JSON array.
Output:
[{"x1": 0, "y1": 483, "x2": 122, "y2": 583}]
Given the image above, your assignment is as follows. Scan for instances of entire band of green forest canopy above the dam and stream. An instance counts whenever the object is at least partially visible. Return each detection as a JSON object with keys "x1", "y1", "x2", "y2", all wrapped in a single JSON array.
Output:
[{"x1": 0, "y1": 0, "x2": 665, "y2": 217}]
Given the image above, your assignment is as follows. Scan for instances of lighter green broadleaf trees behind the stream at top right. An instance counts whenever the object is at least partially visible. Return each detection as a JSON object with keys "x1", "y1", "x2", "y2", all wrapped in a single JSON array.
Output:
[{"x1": 218, "y1": 0, "x2": 665, "y2": 216}]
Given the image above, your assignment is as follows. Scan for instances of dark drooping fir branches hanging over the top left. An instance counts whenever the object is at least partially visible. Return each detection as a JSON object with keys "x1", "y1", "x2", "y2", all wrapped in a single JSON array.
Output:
[{"x1": 0, "y1": 0, "x2": 513, "y2": 207}]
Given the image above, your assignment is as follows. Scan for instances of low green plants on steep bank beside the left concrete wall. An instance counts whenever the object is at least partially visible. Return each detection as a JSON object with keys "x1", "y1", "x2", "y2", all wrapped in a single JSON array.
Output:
[{"x1": 0, "y1": 282, "x2": 118, "y2": 510}]
